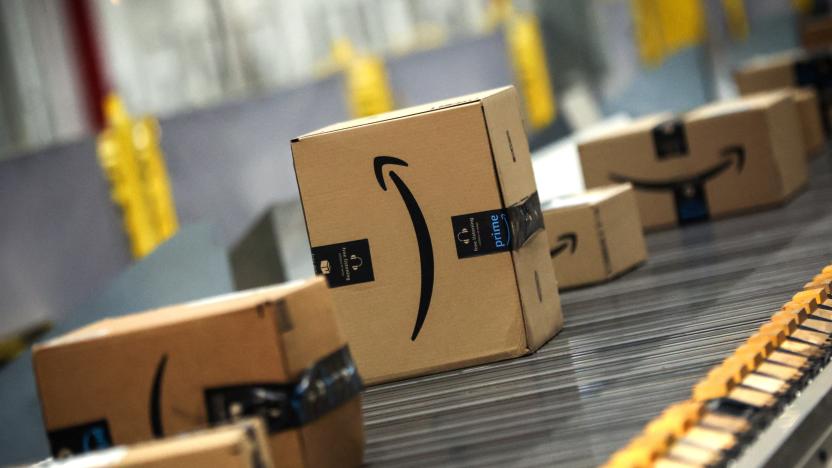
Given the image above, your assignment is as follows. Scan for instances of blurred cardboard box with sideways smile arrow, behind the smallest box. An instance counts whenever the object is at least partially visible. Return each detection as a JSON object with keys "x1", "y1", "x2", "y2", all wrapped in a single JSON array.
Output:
[{"x1": 579, "y1": 91, "x2": 807, "y2": 229}]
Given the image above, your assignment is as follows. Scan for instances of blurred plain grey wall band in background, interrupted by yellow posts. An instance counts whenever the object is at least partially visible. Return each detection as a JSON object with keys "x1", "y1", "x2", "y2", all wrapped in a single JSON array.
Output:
[{"x1": 0, "y1": 34, "x2": 511, "y2": 332}]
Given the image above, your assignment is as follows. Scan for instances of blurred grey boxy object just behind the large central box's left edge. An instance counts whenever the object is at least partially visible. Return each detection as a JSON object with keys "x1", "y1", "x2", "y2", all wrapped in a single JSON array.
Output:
[{"x1": 229, "y1": 200, "x2": 315, "y2": 290}]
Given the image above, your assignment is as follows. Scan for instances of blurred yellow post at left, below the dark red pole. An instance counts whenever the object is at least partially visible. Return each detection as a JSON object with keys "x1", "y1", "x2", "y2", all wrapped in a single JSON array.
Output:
[{"x1": 98, "y1": 94, "x2": 179, "y2": 258}]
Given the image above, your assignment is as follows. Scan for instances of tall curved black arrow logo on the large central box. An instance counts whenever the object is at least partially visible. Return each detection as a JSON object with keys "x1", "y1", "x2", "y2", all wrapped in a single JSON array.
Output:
[{"x1": 373, "y1": 156, "x2": 433, "y2": 340}]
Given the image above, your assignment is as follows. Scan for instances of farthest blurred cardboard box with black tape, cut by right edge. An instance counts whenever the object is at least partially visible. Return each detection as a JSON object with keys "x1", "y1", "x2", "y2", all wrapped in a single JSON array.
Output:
[{"x1": 734, "y1": 51, "x2": 832, "y2": 139}]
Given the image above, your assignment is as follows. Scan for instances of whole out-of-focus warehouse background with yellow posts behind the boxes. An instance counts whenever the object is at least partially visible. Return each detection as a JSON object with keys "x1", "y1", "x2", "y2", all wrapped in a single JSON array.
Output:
[{"x1": 0, "y1": 0, "x2": 829, "y2": 356}]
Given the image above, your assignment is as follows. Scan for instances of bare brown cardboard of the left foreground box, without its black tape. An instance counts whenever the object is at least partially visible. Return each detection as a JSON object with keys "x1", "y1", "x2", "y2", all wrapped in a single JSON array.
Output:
[{"x1": 33, "y1": 278, "x2": 363, "y2": 466}]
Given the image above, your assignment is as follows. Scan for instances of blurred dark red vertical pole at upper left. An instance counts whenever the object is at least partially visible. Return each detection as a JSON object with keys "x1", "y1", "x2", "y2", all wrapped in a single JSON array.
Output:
[{"x1": 64, "y1": 0, "x2": 109, "y2": 130}]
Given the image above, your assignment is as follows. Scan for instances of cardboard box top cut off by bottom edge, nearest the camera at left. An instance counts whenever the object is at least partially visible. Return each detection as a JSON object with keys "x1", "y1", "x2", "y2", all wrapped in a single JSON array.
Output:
[{"x1": 33, "y1": 419, "x2": 274, "y2": 468}]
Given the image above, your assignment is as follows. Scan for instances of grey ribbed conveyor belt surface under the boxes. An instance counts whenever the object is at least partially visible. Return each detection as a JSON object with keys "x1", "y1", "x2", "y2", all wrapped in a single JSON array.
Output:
[{"x1": 364, "y1": 156, "x2": 832, "y2": 466}]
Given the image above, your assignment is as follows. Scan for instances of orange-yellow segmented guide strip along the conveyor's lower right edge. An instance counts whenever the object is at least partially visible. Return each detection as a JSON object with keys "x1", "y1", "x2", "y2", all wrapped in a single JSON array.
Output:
[{"x1": 604, "y1": 265, "x2": 832, "y2": 468}]
